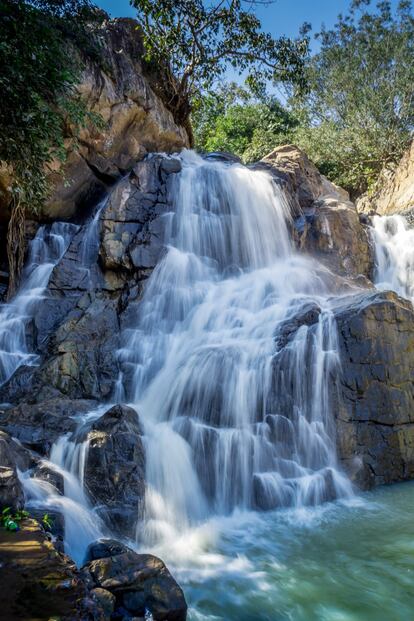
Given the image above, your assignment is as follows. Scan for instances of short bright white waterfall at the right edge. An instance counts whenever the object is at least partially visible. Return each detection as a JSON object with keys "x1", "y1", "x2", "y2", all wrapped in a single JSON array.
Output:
[{"x1": 372, "y1": 216, "x2": 414, "y2": 303}]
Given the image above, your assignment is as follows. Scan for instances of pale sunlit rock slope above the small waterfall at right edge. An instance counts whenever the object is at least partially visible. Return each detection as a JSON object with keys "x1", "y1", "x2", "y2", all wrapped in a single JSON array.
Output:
[{"x1": 357, "y1": 142, "x2": 414, "y2": 215}]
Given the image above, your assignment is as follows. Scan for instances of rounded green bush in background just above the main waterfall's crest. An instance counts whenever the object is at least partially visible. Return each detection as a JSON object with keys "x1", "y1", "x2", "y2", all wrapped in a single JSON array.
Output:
[{"x1": 192, "y1": 83, "x2": 295, "y2": 163}]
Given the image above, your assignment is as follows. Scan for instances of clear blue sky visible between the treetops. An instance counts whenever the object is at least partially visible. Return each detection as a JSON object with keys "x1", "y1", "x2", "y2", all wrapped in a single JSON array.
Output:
[{"x1": 95, "y1": 0, "x2": 398, "y2": 47}]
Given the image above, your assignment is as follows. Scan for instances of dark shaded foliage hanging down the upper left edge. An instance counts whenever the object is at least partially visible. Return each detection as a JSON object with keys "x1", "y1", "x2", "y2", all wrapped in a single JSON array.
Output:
[{"x1": 0, "y1": 0, "x2": 104, "y2": 292}]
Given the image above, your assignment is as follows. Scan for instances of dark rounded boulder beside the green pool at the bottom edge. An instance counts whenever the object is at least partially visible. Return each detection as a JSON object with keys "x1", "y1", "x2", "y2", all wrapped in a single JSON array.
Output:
[{"x1": 83, "y1": 540, "x2": 187, "y2": 621}]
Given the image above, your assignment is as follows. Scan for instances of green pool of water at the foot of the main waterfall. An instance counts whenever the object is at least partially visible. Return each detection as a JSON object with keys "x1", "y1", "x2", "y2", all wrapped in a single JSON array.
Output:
[{"x1": 167, "y1": 483, "x2": 414, "y2": 621}]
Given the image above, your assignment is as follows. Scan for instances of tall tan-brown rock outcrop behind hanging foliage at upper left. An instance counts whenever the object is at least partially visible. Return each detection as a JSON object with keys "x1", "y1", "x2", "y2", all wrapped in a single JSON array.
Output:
[{"x1": 44, "y1": 18, "x2": 188, "y2": 219}]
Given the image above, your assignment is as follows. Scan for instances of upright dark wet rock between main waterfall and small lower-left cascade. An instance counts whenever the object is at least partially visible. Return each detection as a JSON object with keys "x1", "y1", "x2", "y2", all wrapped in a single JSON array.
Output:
[{"x1": 85, "y1": 405, "x2": 145, "y2": 537}]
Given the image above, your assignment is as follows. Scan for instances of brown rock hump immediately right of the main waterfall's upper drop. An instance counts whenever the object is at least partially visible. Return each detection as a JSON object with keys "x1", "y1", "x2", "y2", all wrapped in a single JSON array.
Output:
[{"x1": 259, "y1": 145, "x2": 374, "y2": 279}]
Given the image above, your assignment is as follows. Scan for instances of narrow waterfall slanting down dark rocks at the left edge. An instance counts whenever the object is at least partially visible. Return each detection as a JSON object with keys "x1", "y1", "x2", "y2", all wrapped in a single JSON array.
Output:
[{"x1": 0, "y1": 222, "x2": 78, "y2": 385}]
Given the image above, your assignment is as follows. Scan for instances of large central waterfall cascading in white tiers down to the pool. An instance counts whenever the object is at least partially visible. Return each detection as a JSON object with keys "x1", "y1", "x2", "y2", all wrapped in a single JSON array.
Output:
[{"x1": 120, "y1": 153, "x2": 351, "y2": 542}]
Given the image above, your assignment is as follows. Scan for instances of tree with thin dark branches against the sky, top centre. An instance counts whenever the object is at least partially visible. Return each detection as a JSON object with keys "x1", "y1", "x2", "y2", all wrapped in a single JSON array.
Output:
[{"x1": 131, "y1": 0, "x2": 308, "y2": 142}]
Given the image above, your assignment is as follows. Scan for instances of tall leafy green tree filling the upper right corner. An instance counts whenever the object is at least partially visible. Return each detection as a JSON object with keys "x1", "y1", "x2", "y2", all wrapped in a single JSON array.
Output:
[{"x1": 292, "y1": 0, "x2": 414, "y2": 196}]
